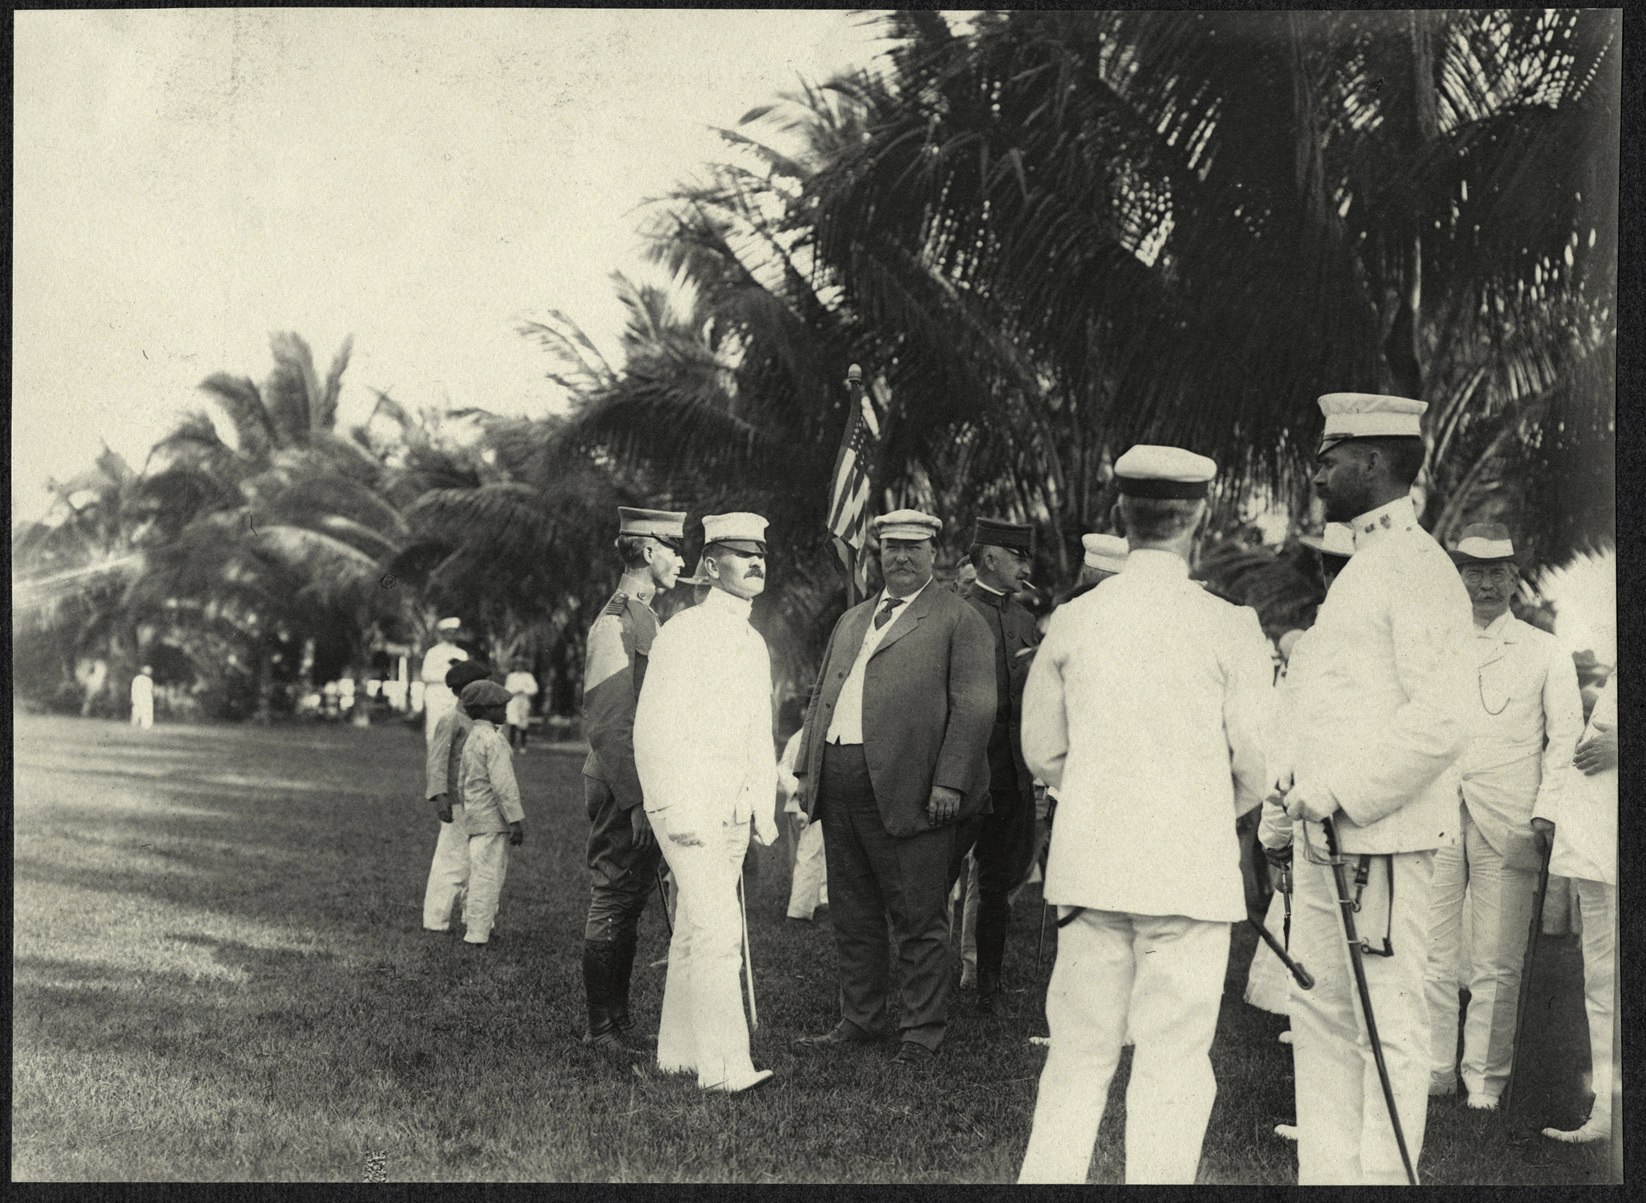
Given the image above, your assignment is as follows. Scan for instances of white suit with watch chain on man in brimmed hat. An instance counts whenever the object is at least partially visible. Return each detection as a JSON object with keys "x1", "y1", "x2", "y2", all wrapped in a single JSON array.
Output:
[{"x1": 1425, "y1": 612, "x2": 1583, "y2": 1103}]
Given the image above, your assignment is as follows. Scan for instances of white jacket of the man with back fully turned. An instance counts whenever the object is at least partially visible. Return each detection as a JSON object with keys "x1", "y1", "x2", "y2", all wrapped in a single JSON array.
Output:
[{"x1": 1022, "y1": 548, "x2": 1274, "y2": 922}]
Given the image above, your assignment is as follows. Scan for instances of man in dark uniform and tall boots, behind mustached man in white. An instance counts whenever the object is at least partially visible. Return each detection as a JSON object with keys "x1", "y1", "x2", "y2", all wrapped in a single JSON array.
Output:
[{"x1": 583, "y1": 505, "x2": 686, "y2": 1053}]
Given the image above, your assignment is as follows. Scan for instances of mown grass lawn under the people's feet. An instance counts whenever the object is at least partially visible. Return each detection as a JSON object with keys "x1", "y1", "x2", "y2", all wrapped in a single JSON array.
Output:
[{"x1": 12, "y1": 716, "x2": 1613, "y2": 1183}]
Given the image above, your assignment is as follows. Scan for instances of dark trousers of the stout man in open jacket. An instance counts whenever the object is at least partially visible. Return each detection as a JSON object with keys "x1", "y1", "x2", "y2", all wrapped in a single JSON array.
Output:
[{"x1": 813, "y1": 744, "x2": 960, "y2": 1052}]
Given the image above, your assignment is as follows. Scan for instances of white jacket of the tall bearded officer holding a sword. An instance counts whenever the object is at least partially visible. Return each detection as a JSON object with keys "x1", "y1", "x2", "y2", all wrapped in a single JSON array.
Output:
[{"x1": 1294, "y1": 497, "x2": 1478, "y2": 854}]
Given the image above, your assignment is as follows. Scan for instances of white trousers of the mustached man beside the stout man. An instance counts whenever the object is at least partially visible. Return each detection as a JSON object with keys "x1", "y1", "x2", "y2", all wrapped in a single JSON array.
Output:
[{"x1": 657, "y1": 820, "x2": 754, "y2": 1086}]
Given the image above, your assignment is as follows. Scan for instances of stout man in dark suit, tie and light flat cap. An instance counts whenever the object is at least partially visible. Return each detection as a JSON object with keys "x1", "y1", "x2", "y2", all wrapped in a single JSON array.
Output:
[{"x1": 795, "y1": 510, "x2": 996, "y2": 1066}]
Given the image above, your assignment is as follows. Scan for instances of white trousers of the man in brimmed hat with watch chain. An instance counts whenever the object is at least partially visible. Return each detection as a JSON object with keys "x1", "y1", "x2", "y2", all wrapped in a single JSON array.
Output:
[{"x1": 1424, "y1": 810, "x2": 1537, "y2": 1099}]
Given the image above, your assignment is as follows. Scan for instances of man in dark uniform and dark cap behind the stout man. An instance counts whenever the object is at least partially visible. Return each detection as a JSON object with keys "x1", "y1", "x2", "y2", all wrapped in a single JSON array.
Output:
[{"x1": 961, "y1": 518, "x2": 1040, "y2": 1015}]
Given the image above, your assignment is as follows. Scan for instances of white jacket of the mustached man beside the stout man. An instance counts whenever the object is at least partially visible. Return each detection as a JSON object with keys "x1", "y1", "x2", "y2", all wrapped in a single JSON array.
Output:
[{"x1": 634, "y1": 589, "x2": 777, "y2": 841}]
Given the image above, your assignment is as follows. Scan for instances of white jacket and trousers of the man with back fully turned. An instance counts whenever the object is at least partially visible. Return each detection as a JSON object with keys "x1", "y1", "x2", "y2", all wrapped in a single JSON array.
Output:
[{"x1": 1019, "y1": 548, "x2": 1272, "y2": 1183}]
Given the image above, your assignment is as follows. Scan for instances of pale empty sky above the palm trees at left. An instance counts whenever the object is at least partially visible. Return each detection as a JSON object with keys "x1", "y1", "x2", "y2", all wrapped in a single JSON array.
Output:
[{"x1": 12, "y1": 8, "x2": 882, "y2": 520}]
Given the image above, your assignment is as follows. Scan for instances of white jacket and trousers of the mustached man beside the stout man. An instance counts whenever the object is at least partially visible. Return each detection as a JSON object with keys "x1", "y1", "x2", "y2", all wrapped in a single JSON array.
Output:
[{"x1": 634, "y1": 588, "x2": 777, "y2": 1089}]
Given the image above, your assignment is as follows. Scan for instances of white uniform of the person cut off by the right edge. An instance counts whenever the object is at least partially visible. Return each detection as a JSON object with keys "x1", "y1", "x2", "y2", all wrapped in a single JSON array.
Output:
[{"x1": 1534, "y1": 673, "x2": 1621, "y2": 1136}]
